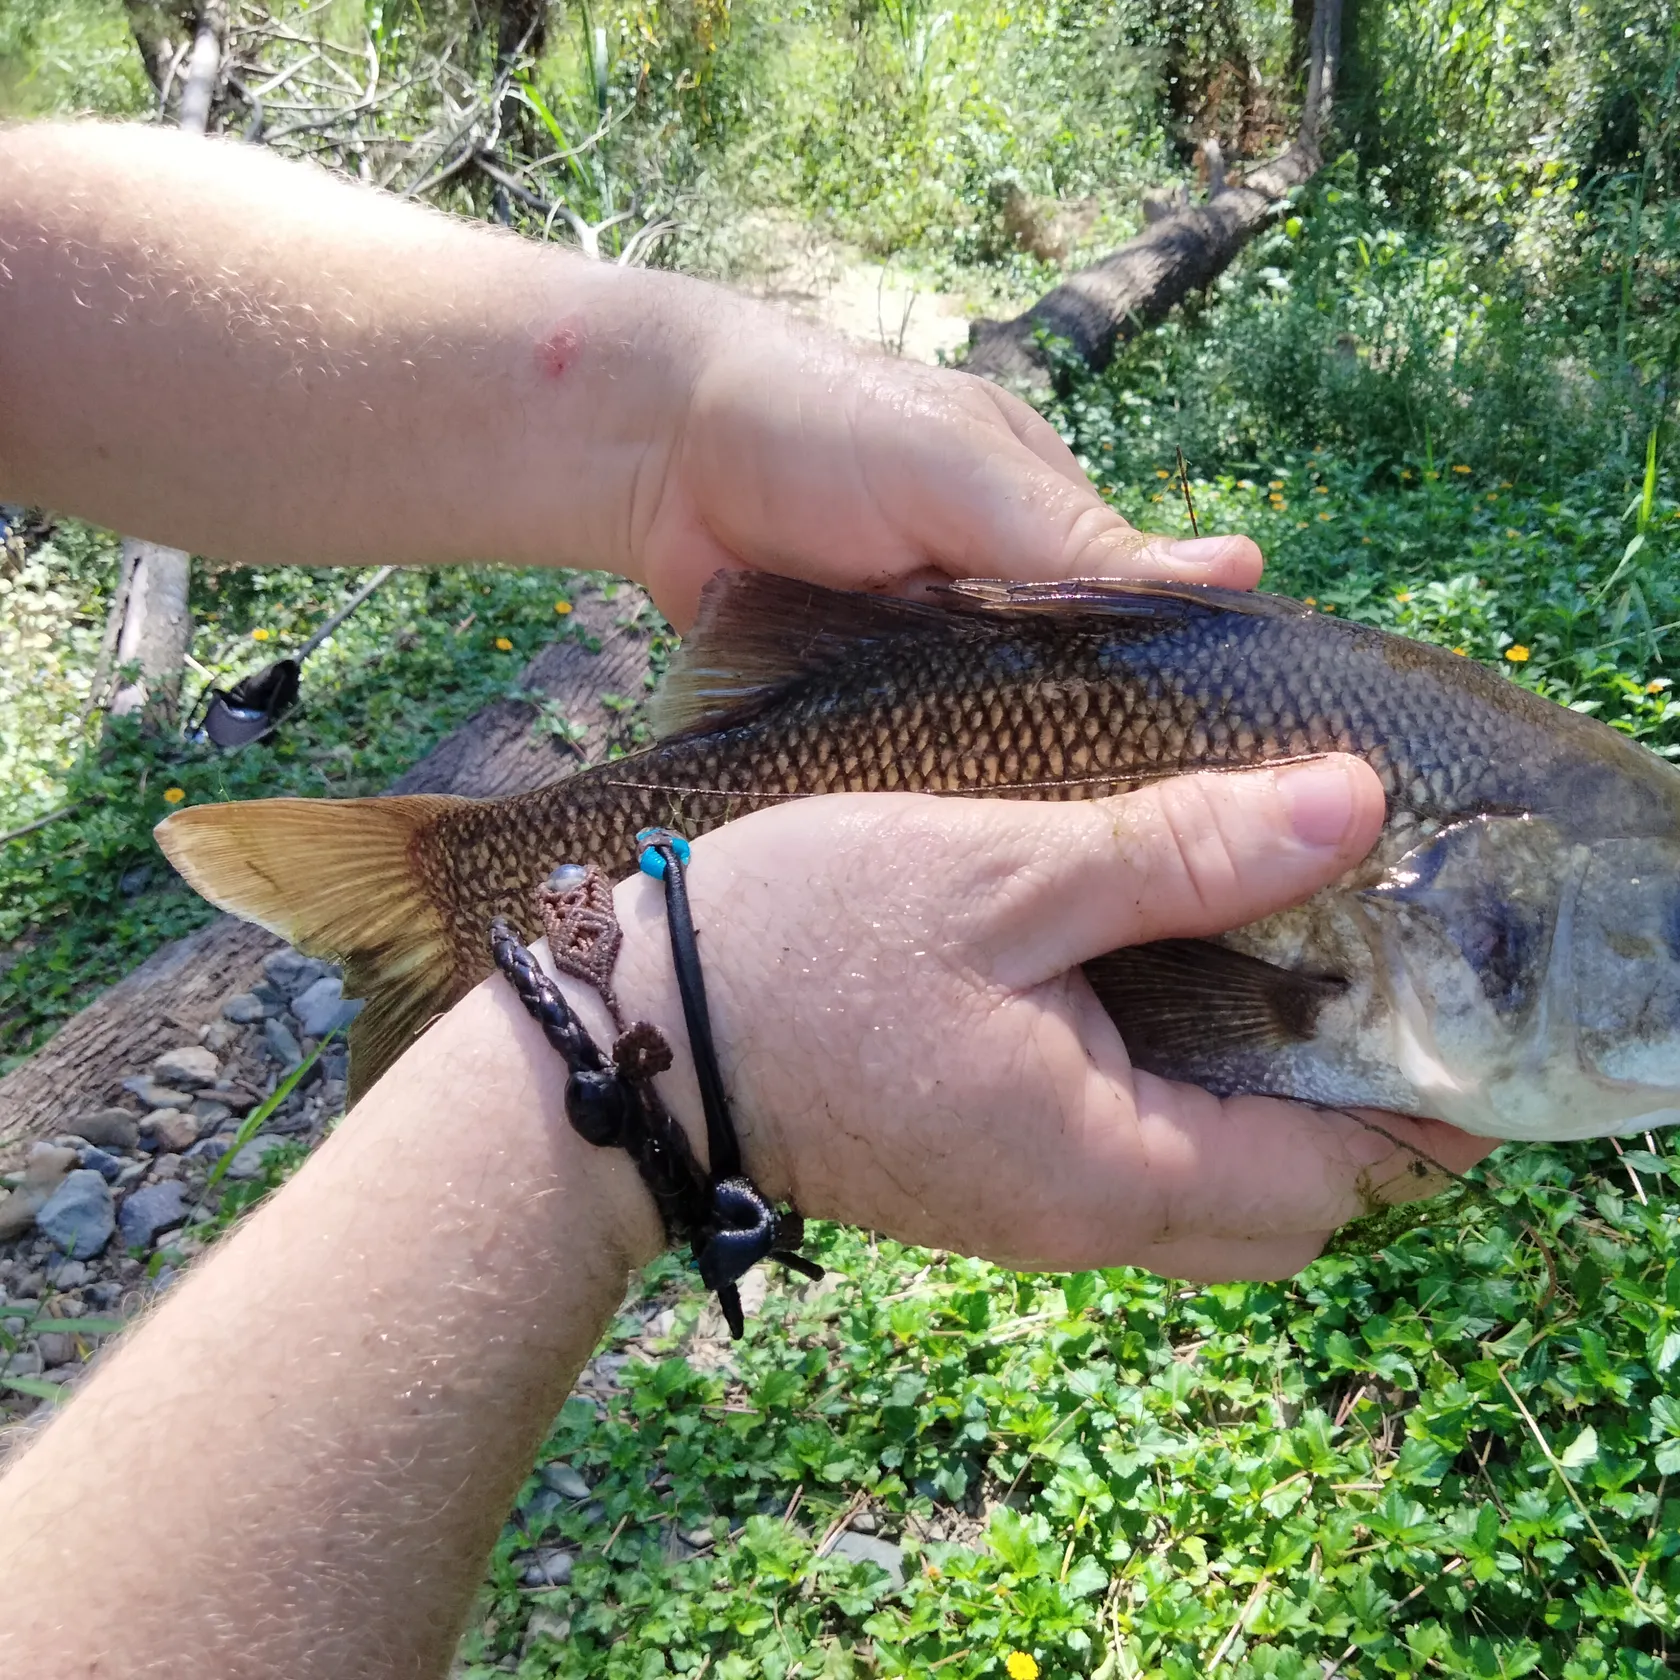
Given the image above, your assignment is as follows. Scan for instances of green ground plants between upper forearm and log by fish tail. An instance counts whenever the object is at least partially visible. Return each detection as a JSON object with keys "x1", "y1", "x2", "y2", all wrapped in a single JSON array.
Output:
[{"x1": 0, "y1": 557, "x2": 641, "y2": 1065}]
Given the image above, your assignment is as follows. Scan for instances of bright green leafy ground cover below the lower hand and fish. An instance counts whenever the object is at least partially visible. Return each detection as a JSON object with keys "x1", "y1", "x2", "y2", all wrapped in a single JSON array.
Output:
[{"x1": 465, "y1": 1144, "x2": 1680, "y2": 1680}]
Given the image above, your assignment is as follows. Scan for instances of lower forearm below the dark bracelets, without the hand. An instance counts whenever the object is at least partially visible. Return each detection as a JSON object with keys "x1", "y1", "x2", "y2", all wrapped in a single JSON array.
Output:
[{"x1": 0, "y1": 954, "x2": 660, "y2": 1680}]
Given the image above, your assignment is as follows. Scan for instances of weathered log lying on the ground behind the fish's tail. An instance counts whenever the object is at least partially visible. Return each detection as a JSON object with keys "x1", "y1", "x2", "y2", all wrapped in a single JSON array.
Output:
[{"x1": 0, "y1": 586, "x2": 648, "y2": 1161}]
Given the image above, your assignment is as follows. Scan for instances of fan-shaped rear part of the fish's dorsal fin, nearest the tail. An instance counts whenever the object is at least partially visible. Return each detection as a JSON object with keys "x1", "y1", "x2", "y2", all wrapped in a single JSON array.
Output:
[{"x1": 652, "y1": 571, "x2": 951, "y2": 738}]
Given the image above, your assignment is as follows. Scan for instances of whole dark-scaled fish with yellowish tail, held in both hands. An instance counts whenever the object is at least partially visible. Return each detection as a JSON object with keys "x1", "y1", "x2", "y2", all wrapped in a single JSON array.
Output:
[{"x1": 147, "y1": 571, "x2": 1680, "y2": 1139}]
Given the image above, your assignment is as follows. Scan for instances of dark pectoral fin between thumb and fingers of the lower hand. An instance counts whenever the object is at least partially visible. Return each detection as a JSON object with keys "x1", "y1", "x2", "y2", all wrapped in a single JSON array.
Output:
[{"x1": 1085, "y1": 939, "x2": 1347, "y2": 1072}]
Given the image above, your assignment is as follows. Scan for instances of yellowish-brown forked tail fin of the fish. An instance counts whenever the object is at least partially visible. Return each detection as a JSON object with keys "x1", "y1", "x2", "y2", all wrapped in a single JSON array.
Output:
[{"x1": 156, "y1": 793, "x2": 477, "y2": 1100}]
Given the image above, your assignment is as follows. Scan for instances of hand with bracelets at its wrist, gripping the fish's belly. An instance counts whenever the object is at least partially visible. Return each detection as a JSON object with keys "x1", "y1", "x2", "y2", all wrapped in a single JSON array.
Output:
[{"x1": 588, "y1": 758, "x2": 1492, "y2": 1278}]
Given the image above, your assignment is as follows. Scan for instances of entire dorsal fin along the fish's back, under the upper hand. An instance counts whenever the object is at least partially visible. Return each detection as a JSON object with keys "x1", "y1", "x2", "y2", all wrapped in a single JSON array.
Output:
[{"x1": 652, "y1": 571, "x2": 1310, "y2": 738}]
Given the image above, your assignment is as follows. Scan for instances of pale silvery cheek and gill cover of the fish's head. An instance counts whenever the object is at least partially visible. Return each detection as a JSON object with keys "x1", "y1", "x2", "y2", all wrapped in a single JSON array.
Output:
[{"x1": 1361, "y1": 816, "x2": 1680, "y2": 1141}]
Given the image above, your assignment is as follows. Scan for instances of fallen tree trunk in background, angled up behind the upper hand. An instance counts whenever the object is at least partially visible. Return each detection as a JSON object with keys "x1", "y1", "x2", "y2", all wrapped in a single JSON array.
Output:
[{"x1": 964, "y1": 0, "x2": 1342, "y2": 395}]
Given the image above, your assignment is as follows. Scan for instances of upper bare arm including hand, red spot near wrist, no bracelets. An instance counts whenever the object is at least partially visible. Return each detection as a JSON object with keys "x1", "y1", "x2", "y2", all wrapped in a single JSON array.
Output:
[{"x1": 0, "y1": 124, "x2": 1260, "y2": 622}]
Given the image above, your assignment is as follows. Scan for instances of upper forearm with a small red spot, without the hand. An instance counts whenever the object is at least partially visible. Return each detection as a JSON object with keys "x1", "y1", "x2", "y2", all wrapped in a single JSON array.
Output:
[{"x1": 0, "y1": 124, "x2": 715, "y2": 575}]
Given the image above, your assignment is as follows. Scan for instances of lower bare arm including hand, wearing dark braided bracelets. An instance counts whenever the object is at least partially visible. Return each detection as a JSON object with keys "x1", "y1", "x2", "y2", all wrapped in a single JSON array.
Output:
[{"x1": 0, "y1": 761, "x2": 1487, "y2": 1680}]
